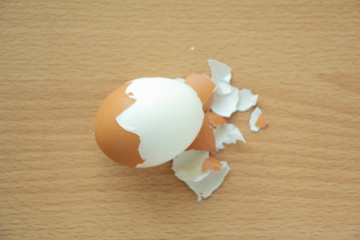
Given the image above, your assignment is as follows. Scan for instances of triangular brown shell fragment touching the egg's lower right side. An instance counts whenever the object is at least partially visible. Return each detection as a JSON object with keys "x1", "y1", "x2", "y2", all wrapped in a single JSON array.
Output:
[{"x1": 187, "y1": 113, "x2": 216, "y2": 153}]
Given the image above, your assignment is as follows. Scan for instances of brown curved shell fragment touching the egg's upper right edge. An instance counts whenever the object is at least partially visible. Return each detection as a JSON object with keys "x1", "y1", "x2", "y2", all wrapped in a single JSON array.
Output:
[{"x1": 185, "y1": 73, "x2": 216, "y2": 112}]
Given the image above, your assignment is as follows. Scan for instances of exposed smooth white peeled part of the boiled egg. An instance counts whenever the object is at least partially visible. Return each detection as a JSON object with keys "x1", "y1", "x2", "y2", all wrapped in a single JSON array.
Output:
[{"x1": 116, "y1": 77, "x2": 204, "y2": 168}]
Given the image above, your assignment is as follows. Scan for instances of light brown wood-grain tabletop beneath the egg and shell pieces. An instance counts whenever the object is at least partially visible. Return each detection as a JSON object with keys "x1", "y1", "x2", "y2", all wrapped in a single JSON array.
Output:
[{"x1": 0, "y1": 0, "x2": 360, "y2": 240}]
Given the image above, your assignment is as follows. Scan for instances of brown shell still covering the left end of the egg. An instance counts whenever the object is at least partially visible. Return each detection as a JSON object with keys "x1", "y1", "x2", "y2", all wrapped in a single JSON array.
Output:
[{"x1": 94, "y1": 82, "x2": 144, "y2": 167}]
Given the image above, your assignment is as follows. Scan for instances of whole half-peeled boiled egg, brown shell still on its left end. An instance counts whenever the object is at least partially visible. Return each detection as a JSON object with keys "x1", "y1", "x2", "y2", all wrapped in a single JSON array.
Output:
[{"x1": 94, "y1": 77, "x2": 204, "y2": 168}]
